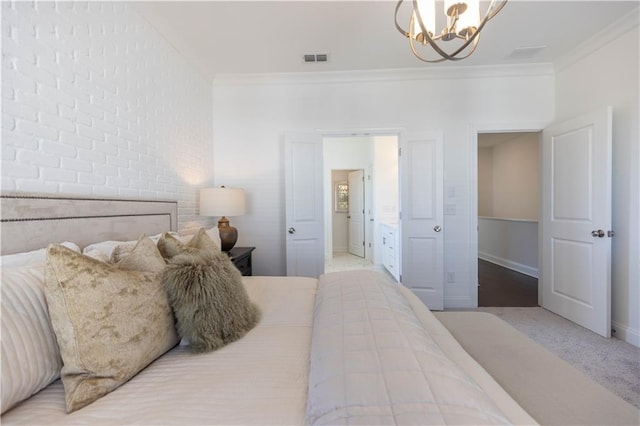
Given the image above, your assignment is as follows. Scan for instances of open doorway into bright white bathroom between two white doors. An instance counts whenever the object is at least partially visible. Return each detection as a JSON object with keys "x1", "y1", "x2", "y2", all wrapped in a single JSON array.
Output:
[{"x1": 322, "y1": 135, "x2": 399, "y2": 272}]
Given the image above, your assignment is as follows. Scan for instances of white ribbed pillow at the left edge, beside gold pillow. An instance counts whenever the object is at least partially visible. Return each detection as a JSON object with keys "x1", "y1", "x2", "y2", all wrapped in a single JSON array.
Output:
[{"x1": 0, "y1": 262, "x2": 62, "y2": 413}]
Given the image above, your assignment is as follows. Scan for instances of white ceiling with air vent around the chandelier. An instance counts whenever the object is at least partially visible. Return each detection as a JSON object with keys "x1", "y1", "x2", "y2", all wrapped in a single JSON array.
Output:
[{"x1": 135, "y1": 0, "x2": 639, "y2": 79}]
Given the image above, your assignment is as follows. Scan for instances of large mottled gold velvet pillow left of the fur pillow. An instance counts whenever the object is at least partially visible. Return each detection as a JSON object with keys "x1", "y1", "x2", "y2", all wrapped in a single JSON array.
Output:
[{"x1": 45, "y1": 238, "x2": 178, "y2": 412}]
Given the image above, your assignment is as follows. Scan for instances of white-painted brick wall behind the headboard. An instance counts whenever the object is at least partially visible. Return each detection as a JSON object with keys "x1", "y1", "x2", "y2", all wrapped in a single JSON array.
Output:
[{"x1": 1, "y1": 1, "x2": 213, "y2": 230}]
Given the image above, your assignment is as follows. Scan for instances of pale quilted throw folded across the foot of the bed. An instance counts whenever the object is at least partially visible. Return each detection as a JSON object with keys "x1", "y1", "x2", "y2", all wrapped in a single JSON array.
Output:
[{"x1": 306, "y1": 271, "x2": 524, "y2": 425}]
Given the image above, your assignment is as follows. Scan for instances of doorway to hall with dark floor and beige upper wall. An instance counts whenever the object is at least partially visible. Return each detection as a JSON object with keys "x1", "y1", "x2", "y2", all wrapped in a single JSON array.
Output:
[{"x1": 477, "y1": 132, "x2": 541, "y2": 307}]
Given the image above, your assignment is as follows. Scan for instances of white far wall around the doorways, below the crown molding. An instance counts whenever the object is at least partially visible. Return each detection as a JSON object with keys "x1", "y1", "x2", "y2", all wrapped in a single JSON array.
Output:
[{"x1": 214, "y1": 67, "x2": 553, "y2": 307}]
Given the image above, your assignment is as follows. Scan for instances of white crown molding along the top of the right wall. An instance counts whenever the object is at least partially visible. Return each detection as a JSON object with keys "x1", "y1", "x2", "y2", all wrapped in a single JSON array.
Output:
[{"x1": 554, "y1": 6, "x2": 640, "y2": 72}]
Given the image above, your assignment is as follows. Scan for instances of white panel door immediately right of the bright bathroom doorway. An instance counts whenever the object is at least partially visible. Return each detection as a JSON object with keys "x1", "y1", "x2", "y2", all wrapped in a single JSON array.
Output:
[{"x1": 400, "y1": 133, "x2": 444, "y2": 310}]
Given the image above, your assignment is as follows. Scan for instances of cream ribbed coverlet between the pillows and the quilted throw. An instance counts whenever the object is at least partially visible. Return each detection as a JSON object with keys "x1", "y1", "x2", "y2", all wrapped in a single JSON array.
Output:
[{"x1": 2, "y1": 277, "x2": 317, "y2": 425}]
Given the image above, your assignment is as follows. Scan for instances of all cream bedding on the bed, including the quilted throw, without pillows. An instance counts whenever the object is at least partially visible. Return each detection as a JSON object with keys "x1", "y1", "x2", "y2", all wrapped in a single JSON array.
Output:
[{"x1": 2, "y1": 271, "x2": 535, "y2": 425}]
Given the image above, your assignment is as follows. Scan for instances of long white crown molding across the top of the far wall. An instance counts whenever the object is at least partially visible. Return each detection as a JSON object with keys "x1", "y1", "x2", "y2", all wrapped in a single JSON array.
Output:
[{"x1": 213, "y1": 63, "x2": 554, "y2": 87}]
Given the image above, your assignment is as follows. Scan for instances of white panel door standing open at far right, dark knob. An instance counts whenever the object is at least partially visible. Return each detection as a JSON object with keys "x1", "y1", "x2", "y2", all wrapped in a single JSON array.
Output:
[{"x1": 540, "y1": 108, "x2": 612, "y2": 337}]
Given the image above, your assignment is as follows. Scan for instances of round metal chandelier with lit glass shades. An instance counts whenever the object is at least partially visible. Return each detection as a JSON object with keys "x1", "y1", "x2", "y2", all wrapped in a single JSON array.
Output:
[{"x1": 395, "y1": 0, "x2": 507, "y2": 63}]
